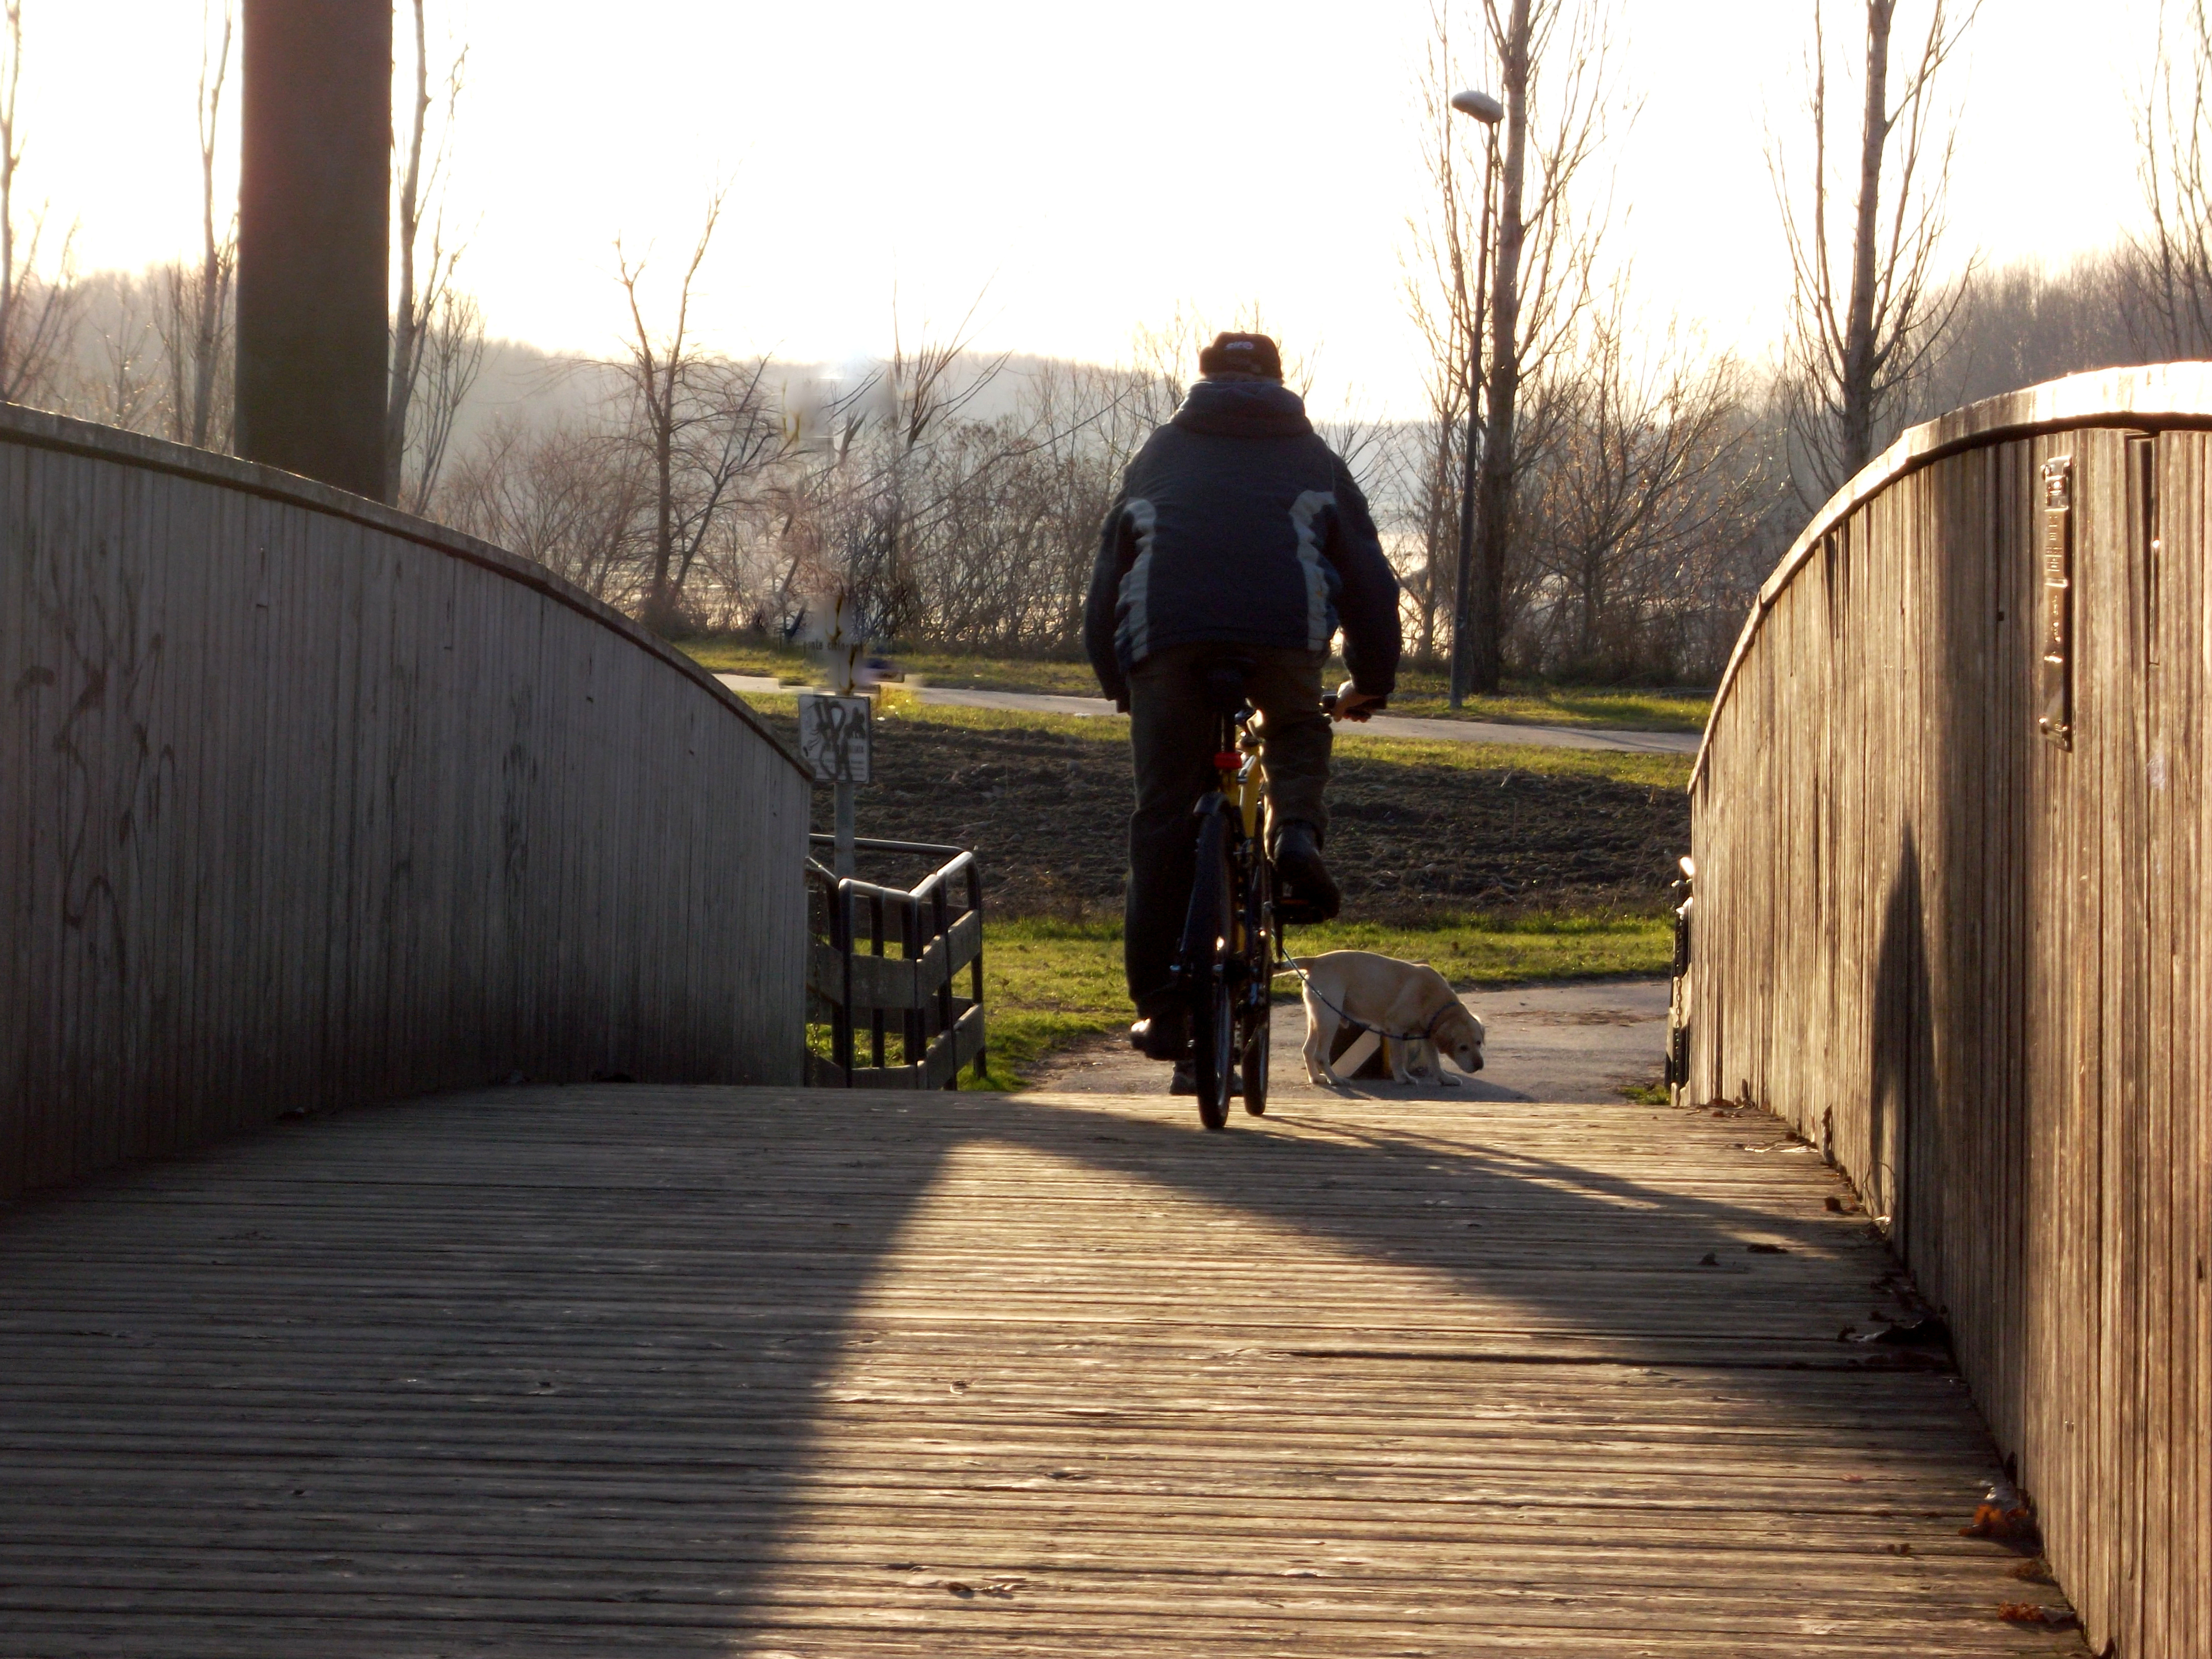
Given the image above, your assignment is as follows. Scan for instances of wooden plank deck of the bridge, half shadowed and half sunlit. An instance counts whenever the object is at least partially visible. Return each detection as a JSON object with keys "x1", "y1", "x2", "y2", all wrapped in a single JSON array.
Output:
[{"x1": 0, "y1": 1088, "x2": 2079, "y2": 1659}]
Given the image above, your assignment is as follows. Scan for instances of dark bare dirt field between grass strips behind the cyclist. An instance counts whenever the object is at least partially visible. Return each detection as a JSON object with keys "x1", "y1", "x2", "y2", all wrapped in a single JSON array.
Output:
[{"x1": 763, "y1": 710, "x2": 1690, "y2": 920}]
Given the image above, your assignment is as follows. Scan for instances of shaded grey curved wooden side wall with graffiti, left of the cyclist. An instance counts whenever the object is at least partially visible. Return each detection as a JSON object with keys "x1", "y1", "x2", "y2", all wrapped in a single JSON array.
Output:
[{"x1": 0, "y1": 407, "x2": 810, "y2": 1195}]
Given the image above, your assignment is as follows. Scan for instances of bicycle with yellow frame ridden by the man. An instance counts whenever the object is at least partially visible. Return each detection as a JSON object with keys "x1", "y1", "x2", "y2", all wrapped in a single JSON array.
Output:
[{"x1": 1173, "y1": 659, "x2": 1385, "y2": 1128}]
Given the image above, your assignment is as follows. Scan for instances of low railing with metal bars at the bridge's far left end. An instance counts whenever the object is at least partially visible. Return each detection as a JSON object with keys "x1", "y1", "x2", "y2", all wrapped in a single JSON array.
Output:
[{"x1": 807, "y1": 836, "x2": 984, "y2": 1088}]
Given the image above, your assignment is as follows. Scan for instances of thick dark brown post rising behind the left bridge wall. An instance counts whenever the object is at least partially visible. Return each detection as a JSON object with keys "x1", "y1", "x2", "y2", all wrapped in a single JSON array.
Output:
[{"x1": 237, "y1": 0, "x2": 392, "y2": 498}]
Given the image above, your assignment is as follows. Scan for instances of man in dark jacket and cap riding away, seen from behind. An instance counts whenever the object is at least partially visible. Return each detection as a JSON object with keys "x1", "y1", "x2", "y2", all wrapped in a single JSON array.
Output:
[{"x1": 1084, "y1": 334, "x2": 1400, "y2": 1086}]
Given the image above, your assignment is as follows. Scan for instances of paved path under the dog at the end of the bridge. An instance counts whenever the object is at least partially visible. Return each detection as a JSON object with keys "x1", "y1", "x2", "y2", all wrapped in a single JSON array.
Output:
[{"x1": 1037, "y1": 980, "x2": 1668, "y2": 1106}]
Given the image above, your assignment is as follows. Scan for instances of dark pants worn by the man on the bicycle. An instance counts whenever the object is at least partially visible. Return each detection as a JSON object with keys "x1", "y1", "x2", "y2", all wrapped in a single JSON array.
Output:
[{"x1": 1121, "y1": 646, "x2": 1332, "y2": 1015}]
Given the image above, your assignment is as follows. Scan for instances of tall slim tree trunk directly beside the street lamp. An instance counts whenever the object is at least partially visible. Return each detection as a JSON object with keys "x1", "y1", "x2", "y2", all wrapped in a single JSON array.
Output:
[{"x1": 1466, "y1": 0, "x2": 1528, "y2": 692}]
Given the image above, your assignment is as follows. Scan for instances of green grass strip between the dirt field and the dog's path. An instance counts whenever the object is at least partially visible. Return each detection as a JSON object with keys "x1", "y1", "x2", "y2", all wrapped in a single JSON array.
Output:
[{"x1": 960, "y1": 913, "x2": 1674, "y2": 1091}]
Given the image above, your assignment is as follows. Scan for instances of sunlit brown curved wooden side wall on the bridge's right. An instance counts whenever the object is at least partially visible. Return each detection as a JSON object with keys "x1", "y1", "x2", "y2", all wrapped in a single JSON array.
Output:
[{"x1": 1686, "y1": 363, "x2": 2212, "y2": 1659}]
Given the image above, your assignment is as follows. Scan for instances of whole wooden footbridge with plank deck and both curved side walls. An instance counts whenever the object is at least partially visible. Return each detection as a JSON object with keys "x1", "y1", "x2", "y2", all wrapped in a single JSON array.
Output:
[{"x1": 0, "y1": 382, "x2": 2212, "y2": 1659}]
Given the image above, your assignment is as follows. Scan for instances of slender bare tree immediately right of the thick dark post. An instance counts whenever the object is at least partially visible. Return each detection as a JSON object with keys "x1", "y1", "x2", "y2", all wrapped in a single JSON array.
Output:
[{"x1": 385, "y1": 0, "x2": 484, "y2": 511}]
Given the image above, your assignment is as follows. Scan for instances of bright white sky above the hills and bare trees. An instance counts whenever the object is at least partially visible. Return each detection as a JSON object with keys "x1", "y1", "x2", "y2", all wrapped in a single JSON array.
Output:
[{"x1": 22, "y1": 0, "x2": 2157, "y2": 414}]
